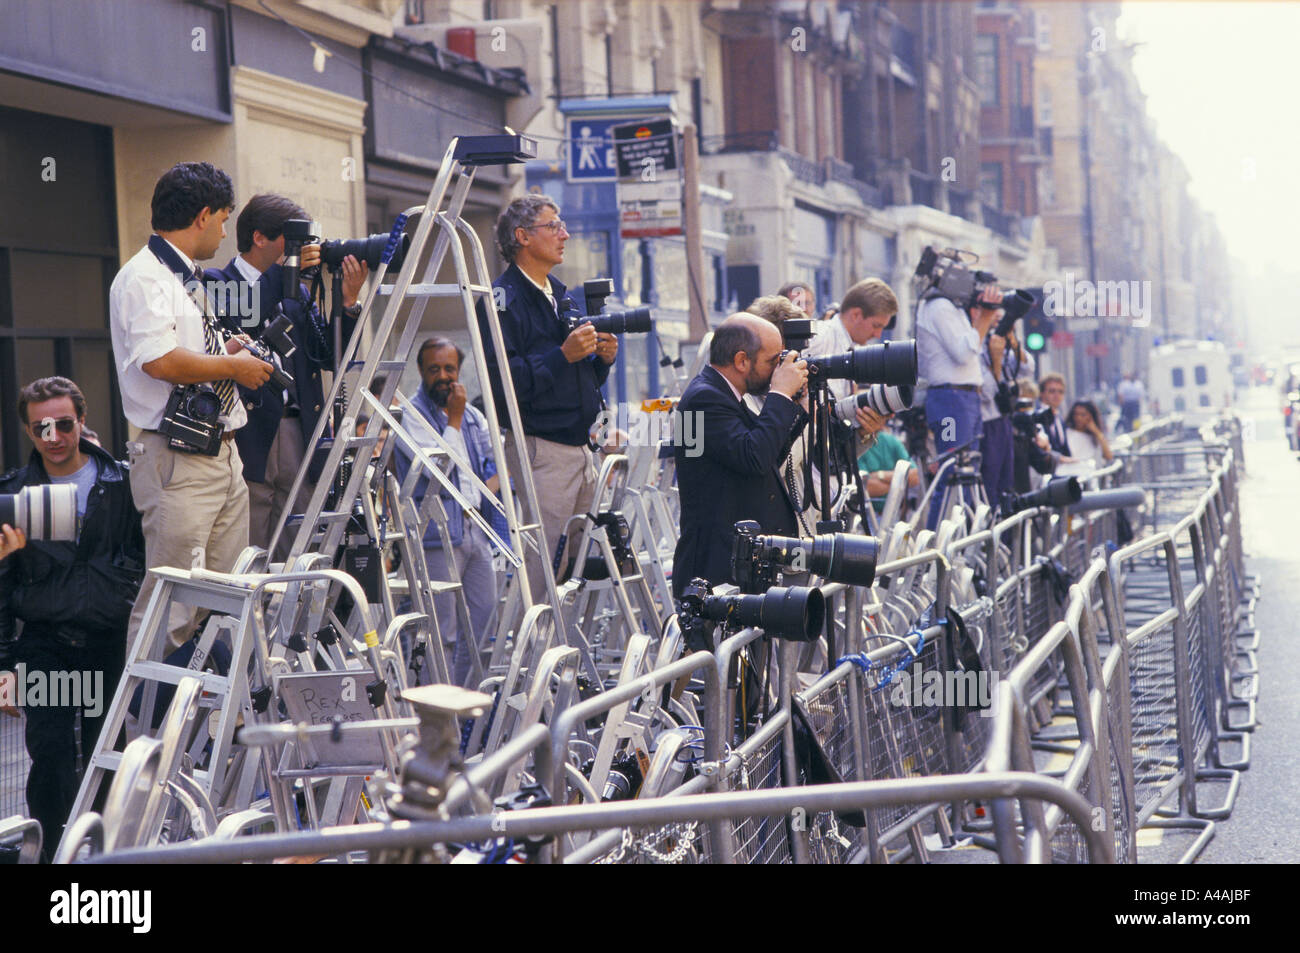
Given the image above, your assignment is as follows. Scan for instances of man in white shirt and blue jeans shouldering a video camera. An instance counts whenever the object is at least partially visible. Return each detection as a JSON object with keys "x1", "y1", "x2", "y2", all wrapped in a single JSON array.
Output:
[{"x1": 917, "y1": 285, "x2": 1001, "y2": 529}]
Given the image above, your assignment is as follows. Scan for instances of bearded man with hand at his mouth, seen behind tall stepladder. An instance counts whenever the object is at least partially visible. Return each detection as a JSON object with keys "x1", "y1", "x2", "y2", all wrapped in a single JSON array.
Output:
[{"x1": 394, "y1": 338, "x2": 504, "y2": 685}]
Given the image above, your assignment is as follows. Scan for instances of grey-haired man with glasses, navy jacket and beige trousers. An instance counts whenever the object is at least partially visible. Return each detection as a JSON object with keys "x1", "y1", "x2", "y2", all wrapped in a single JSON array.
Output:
[{"x1": 478, "y1": 194, "x2": 619, "y2": 598}]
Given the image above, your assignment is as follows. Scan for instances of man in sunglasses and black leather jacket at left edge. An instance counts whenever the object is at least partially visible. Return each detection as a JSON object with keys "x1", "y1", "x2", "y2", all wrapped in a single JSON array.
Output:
[{"x1": 0, "y1": 377, "x2": 144, "y2": 859}]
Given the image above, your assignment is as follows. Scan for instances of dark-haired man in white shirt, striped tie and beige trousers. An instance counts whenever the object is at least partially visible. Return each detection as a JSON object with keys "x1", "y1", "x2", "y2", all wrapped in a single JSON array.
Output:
[{"x1": 109, "y1": 163, "x2": 272, "y2": 645}]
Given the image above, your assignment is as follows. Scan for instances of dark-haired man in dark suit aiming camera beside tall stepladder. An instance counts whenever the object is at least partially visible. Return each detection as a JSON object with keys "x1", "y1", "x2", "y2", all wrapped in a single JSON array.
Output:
[{"x1": 205, "y1": 194, "x2": 368, "y2": 560}]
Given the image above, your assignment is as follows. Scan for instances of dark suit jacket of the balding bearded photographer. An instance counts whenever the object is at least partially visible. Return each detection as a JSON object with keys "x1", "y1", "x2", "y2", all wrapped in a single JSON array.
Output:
[{"x1": 672, "y1": 367, "x2": 806, "y2": 597}]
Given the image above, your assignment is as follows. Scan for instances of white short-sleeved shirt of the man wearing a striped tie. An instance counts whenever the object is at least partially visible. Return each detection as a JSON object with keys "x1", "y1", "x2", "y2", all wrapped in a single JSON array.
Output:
[{"x1": 108, "y1": 237, "x2": 248, "y2": 430}]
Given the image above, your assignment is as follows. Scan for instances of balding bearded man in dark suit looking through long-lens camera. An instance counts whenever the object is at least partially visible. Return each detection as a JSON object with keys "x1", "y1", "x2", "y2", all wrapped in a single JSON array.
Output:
[{"x1": 672, "y1": 315, "x2": 807, "y2": 598}]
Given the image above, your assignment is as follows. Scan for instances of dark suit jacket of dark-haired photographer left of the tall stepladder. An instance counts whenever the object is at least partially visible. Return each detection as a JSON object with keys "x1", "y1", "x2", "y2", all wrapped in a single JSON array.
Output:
[{"x1": 204, "y1": 259, "x2": 334, "y2": 484}]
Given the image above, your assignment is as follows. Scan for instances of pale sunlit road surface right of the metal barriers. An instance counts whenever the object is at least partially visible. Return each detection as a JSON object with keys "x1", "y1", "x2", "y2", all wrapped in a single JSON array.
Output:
[{"x1": 1200, "y1": 386, "x2": 1300, "y2": 863}]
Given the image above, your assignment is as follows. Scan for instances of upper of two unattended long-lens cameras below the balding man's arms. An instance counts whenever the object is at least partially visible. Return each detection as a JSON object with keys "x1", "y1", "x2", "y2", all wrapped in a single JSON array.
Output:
[{"x1": 732, "y1": 520, "x2": 879, "y2": 593}]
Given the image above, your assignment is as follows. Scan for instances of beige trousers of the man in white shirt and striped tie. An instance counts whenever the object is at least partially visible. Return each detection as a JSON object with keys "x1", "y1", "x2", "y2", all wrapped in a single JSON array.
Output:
[{"x1": 126, "y1": 430, "x2": 248, "y2": 651}]
